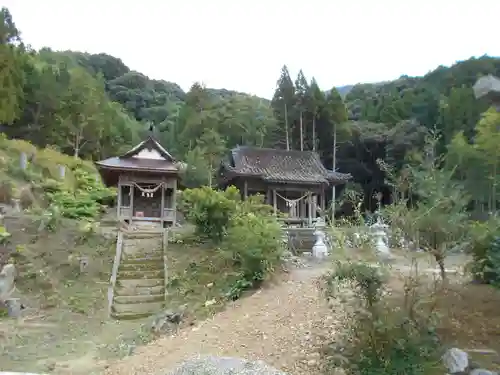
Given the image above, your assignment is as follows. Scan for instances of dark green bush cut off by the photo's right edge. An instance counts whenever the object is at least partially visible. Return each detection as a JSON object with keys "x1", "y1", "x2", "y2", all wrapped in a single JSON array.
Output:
[{"x1": 468, "y1": 217, "x2": 500, "y2": 286}]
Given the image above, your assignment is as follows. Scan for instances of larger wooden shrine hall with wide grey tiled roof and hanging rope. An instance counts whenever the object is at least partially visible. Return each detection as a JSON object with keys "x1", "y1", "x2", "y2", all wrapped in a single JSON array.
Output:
[{"x1": 218, "y1": 146, "x2": 351, "y2": 225}]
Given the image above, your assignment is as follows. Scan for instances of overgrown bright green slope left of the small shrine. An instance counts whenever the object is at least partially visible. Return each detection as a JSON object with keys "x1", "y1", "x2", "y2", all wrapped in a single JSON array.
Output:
[{"x1": 0, "y1": 134, "x2": 115, "y2": 219}]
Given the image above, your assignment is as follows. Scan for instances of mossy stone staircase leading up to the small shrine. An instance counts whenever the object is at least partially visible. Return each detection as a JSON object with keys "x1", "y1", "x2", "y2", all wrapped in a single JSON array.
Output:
[{"x1": 108, "y1": 228, "x2": 167, "y2": 319}]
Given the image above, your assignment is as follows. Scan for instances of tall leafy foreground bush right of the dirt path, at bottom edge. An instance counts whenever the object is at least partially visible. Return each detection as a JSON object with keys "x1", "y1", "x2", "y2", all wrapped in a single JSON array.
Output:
[{"x1": 324, "y1": 263, "x2": 441, "y2": 375}]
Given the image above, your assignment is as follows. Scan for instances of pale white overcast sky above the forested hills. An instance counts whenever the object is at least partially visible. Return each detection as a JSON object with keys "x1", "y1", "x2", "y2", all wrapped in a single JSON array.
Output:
[{"x1": 0, "y1": 0, "x2": 500, "y2": 98}]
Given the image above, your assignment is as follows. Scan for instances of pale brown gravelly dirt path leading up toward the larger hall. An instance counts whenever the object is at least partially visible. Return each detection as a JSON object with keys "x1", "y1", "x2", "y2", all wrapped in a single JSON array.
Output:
[{"x1": 106, "y1": 265, "x2": 336, "y2": 375}]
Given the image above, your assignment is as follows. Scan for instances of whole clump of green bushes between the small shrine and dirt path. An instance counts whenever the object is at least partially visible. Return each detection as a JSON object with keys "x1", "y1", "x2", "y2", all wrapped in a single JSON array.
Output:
[{"x1": 179, "y1": 187, "x2": 282, "y2": 299}]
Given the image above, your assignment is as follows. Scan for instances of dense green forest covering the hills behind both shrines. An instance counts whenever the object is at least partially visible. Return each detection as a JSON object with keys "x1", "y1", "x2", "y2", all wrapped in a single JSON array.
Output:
[{"x1": 0, "y1": 8, "x2": 500, "y2": 210}]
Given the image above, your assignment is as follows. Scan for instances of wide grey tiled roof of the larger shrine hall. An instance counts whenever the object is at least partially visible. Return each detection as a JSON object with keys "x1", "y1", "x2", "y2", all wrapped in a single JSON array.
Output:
[{"x1": 221, "y1": 146, "x2": 351, "y2": 184}]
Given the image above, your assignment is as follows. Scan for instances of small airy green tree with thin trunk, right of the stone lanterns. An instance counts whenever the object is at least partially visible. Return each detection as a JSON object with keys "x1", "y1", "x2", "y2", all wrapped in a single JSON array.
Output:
[{"x1": 382, "y1": 137, "x2": 469, "y2": 279}]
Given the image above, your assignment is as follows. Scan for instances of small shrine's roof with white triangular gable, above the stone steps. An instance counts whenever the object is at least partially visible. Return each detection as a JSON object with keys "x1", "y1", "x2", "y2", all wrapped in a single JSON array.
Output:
[{"x1": 96, "y1": 136, "x2": 179, "y2": 173}]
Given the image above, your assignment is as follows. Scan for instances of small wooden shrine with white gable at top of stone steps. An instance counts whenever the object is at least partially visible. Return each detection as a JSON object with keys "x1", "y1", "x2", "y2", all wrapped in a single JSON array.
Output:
[{"x1": 96, "y1": 136, "x2": 180, "y2": 227}]
